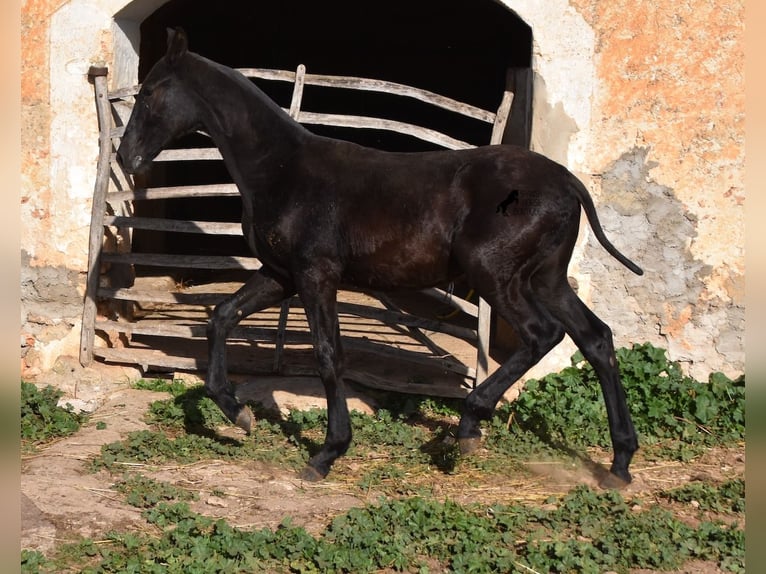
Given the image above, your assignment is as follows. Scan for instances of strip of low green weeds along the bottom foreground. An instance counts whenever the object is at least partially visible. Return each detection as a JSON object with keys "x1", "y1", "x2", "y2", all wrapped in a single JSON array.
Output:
[{"x1": 22, "y1": 486, "x2": 744, "y2": 574}]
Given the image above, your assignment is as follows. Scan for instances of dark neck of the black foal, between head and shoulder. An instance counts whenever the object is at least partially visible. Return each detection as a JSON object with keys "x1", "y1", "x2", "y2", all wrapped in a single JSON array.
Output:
[{"x1": 184, "y1": 54, "x2": 309, "y2": 171}]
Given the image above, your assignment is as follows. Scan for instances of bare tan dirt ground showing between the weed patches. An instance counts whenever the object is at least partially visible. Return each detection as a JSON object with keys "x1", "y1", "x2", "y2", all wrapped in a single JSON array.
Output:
[{"x1": 21, "y1": 358, "x2": 745, "y2": 574}]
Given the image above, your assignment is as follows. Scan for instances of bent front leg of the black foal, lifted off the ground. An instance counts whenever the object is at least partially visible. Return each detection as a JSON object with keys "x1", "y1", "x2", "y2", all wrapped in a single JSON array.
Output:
[{"x1": 205, "y1": 270, "x2": 293, "y2": 432}]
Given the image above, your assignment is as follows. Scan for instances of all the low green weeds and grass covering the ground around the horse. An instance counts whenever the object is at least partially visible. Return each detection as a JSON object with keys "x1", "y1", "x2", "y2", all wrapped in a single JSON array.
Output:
[{"x1": 21, "y1": 345, "x2": 745, "y2": 574}]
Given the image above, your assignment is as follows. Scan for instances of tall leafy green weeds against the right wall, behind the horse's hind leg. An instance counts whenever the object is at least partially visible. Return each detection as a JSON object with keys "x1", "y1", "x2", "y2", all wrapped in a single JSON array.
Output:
[{"x1": 508, "y1": 343, "x2": 745, "y2": 460}]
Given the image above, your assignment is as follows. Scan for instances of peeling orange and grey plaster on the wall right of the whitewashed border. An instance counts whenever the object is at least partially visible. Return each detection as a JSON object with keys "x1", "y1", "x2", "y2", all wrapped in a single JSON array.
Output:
[{"x1": 573, "y1": 0, "x2": 744, "y2": 379}]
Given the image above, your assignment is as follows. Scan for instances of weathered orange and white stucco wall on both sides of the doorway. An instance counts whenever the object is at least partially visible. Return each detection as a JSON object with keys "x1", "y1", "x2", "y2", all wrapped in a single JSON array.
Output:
[{"x1": 21, "y1": 0, "x2": 744, "y2": 378}]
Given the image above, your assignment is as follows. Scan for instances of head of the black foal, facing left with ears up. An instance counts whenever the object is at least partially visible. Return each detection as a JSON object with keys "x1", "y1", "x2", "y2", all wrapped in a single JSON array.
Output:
[{"x1": 117, "y1": 28, "x2": 202, "y2": 173}]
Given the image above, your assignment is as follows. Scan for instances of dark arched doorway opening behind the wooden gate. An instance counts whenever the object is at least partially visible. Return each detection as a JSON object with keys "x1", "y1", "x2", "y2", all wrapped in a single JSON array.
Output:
[{"x1": 133, "y1": 0, "x2": 532, "y2": 279}]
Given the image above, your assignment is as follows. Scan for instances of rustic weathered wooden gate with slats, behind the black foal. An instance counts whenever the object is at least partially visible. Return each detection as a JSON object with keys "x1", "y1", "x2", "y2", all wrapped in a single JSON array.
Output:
[{"x1": 80, "y1": 65, "x2": 513, "y2": 397}]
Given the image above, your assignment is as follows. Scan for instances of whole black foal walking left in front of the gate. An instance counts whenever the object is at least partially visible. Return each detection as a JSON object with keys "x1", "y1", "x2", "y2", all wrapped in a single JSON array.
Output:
[{"x1": 117, "y1": 29, "x2": 643, "y2": 486}]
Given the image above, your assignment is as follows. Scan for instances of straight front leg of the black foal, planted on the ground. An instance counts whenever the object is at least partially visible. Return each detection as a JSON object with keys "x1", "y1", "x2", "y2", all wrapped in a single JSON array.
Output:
[{"x1": 298, "y1": 263, "x2": 351, "y2": 481}]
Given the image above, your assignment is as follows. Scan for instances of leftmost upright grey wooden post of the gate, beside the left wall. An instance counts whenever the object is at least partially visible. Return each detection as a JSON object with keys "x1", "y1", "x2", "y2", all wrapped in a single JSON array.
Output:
[{"x1": 80, "y1": 66, "x2": 112, "y2": 366}]
